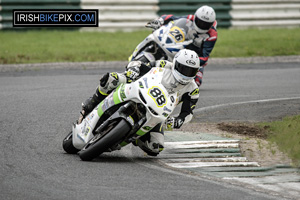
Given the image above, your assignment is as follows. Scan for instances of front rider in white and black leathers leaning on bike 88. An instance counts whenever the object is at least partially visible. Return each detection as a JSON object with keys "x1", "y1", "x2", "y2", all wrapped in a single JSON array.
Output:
[{"x1": 78, "y1": 49, "x2": 200, "y2": 156}]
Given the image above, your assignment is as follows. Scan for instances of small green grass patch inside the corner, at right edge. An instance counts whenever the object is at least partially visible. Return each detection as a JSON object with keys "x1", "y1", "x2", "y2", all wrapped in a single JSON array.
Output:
[{"x1": 259, "y1": 115, "x2": 300, "y2": 167}]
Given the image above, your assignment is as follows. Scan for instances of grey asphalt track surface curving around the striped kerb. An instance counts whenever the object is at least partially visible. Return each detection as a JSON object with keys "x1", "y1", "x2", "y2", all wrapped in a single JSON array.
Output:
[{"x1": 0, "y1": 63, "x2": 300, "y2": 200}]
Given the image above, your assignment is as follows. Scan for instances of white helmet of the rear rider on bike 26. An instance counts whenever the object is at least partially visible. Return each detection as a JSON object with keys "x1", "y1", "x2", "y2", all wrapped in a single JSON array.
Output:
[{"x1": 193, "y1": 6, "x2": 216, "y2": 33}]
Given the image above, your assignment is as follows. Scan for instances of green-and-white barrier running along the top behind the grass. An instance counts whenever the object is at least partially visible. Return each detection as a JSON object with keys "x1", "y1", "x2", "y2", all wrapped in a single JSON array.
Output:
[{"x1": 0, "y1": 0, "x2": 300, "y2": 31}]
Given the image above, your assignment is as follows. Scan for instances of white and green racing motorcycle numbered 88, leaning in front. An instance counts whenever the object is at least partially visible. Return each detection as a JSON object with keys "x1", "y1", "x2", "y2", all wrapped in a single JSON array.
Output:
[{"x1": 63, "y1": 67, "x2": 178, "y2": 161}]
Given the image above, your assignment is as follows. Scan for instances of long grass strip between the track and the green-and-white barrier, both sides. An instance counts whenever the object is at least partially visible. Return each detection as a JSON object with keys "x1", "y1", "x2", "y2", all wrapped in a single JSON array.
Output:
[{"x1": 0, "y1": 28, "x2": 300, "y2": 64}]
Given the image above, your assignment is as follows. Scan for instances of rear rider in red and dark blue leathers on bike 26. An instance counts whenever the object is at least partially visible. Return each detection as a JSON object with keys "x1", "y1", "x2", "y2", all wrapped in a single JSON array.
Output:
[{"x1": 146, "y1": 5, "x2": 218, "y2": 87}]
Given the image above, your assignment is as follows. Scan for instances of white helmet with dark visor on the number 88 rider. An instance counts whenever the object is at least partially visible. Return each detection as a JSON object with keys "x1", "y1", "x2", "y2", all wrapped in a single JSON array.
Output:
[{"x1": 172, "y1": 49, "x2": 200, "y2": 85}]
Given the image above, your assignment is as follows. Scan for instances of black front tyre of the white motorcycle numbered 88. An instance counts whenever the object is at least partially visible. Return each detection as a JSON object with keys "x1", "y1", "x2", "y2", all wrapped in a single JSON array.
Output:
[{"x1": 78, "y1": 119, "x2": 131, "y2": 161}]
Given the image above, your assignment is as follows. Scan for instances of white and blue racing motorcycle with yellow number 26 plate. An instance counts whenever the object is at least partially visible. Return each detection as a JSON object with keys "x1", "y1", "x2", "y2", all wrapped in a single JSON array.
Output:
[{"x1": 128, "y1": 19, "x2": 193, "y2": 63}]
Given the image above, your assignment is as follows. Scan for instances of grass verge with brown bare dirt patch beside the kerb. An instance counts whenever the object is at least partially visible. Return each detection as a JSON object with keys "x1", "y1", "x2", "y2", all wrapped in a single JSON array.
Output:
[{"x1": 217, "y1": 115, "x2": 300, "y2": 167}]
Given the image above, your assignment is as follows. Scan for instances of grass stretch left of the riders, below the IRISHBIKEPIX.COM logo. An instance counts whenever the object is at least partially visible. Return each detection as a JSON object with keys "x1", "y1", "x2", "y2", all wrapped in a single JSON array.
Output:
[{"x1": 0, "y1": 30, "x2": 149, "y2": 64}]
